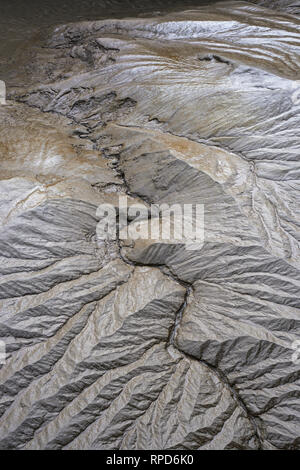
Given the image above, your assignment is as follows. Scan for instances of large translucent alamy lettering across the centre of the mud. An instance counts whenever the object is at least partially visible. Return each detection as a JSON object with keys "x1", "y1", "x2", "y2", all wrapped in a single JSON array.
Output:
[{"x1": 96, "y1": 196, "x2": 204, "y2": 250}]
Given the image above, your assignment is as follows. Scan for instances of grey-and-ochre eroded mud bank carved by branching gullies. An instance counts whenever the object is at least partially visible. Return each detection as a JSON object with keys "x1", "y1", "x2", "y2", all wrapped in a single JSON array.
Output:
[{"x1": 0, "y1": 1, "x2": 300, "y2": 449}]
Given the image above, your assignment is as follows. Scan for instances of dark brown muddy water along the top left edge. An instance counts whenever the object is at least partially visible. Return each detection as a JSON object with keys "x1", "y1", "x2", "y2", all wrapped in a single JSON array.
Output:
[{"x1": 0, "y1": 0, "x2": 218, "y2": 76}]
